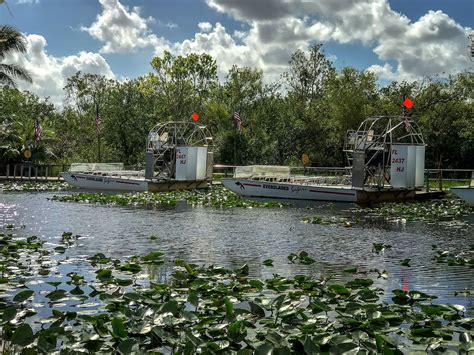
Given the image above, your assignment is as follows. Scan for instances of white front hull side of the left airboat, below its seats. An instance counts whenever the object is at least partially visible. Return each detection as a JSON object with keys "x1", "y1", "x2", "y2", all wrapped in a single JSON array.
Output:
[{"x1": 61, "y1": 173, "x2": 148, "y2": 191}]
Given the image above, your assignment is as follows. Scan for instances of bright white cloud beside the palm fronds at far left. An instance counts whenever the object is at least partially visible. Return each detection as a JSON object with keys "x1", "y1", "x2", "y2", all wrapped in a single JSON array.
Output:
[{"x1": 5, "y1": 34, "x2": 115, "y2": 105}]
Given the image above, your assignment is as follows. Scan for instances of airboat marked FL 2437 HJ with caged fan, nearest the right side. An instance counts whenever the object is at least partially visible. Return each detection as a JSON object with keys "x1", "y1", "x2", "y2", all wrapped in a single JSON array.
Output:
[{"x1": 221, "y1": 116, "x2": 434, "y2": 204}]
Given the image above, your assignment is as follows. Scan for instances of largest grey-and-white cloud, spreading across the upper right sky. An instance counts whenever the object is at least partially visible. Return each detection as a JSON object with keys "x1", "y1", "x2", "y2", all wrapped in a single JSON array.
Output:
[{"x1": 207, "y1": 0, "x2": 472, "y2": 80}]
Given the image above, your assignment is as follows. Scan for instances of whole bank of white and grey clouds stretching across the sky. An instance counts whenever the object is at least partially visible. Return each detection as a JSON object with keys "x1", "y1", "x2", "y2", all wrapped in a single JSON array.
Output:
[{"x1": 9, "y1": 0, "x2": 472, "y2": 102}]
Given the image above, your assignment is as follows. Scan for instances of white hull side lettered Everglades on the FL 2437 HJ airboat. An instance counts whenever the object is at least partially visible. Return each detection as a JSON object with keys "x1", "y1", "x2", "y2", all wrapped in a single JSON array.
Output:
[{"x1": 221, "y1": 179, "x2": 357, "y2": 202}]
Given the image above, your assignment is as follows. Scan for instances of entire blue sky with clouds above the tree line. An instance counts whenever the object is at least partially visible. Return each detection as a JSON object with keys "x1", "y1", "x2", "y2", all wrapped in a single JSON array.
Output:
[{"x1": 0, "y1": 0, "x2": 474, "y2": 105}]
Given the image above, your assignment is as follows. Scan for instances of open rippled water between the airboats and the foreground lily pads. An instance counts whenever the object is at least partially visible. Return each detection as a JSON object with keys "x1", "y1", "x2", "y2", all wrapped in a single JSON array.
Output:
[{"x1": 0, "y1": 193, "x2": 474, "y2": 307}]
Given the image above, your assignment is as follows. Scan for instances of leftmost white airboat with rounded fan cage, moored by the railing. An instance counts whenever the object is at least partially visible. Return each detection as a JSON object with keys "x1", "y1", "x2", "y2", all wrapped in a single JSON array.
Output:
[{"x1": 61, "y1": 121, "x2": 213, "y2": 192}]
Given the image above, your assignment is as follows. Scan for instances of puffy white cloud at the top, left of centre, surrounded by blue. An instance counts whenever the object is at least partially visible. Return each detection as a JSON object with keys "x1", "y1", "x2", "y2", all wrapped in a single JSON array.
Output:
[{"x1": 81, "y1": 0, "x2": 169, "y2": 53}]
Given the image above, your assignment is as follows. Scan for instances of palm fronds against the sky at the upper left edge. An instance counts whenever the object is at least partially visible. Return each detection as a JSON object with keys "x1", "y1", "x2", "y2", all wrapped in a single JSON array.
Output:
[{"x1": 0, "y1": 25, "x2": 32, "y2": 87}]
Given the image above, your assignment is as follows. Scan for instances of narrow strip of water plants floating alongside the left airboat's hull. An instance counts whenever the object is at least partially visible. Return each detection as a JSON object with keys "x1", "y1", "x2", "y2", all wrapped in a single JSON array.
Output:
[{"x1": 52, "y1": 186, "x2": 283, "y2": 208}]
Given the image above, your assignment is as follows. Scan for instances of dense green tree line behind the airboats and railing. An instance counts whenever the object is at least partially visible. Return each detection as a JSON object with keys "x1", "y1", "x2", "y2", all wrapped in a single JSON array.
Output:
[{"x1": 0, "y1": 44, "x2": 474, "y2": 168}]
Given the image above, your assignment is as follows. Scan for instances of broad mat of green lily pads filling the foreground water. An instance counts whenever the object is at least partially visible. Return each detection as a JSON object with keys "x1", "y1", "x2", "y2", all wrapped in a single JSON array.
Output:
[{"x1": 0, "y1": 233, "x2": 474, "y2": 354}]
